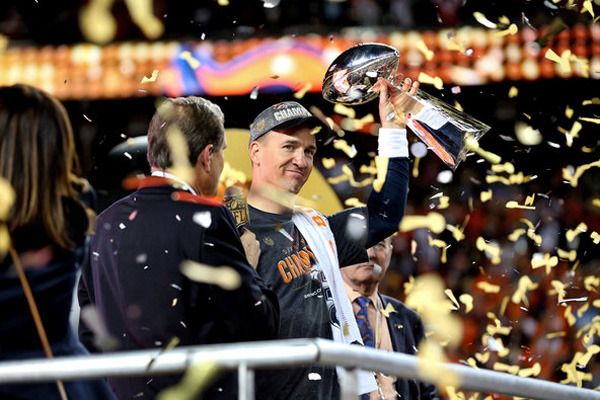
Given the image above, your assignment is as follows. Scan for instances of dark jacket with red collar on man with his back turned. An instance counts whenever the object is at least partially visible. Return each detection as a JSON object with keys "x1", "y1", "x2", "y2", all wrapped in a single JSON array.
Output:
[{"x1": 78, "y1": 177, "x2": 279, "y2": 398}]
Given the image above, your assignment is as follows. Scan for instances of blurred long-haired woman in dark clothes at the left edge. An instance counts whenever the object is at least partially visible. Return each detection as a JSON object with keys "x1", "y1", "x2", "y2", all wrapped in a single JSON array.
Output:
[{"x1": 0, "y1": 85, "x2": 113, "y2": 399}]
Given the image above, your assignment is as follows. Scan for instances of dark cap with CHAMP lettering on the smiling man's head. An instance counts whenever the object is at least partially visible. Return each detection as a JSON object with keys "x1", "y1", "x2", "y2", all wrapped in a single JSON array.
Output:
[{"x1": 250, "y1": 101, "x2": 333, "y2": 144}]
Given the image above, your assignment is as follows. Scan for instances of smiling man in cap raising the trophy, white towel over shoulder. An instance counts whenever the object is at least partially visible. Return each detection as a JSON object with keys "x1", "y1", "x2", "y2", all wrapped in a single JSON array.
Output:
[{"x1": 248, "y1": 76, "x2": 418, "y2": 400}]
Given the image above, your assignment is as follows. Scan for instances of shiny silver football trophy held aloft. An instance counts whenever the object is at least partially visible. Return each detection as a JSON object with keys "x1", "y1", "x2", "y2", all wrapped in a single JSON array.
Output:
[{"x1": 322, "y1": 43, "x2": 490, "y2": 168}]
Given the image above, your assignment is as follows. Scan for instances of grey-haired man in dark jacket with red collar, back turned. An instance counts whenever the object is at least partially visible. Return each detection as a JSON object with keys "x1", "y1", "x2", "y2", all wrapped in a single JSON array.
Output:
[{"x1": 78, "y1": 97, "x2": 279, "y2": 399}]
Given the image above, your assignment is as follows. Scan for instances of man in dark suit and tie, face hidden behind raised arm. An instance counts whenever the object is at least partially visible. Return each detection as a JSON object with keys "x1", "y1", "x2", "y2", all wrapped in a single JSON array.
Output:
[{"x1": 341, "y1": 237, "x2": 438, "y2": 399}]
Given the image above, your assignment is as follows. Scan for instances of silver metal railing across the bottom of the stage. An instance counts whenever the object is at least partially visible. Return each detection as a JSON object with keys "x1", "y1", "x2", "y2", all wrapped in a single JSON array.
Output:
[{"x1": 0, "y1": 339, "x2": 600, "y2": 400}]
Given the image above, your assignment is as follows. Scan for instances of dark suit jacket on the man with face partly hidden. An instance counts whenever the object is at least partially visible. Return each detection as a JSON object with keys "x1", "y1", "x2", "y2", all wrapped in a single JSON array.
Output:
[{"x1": 380, "y1": 294, "x2": 438, "y2": 400}]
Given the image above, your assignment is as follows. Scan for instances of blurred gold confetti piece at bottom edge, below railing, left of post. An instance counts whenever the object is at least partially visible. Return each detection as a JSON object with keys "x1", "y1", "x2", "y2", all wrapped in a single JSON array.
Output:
[{"x1": 158, "y1": 360, "x2": 221, "y2": 400}]
